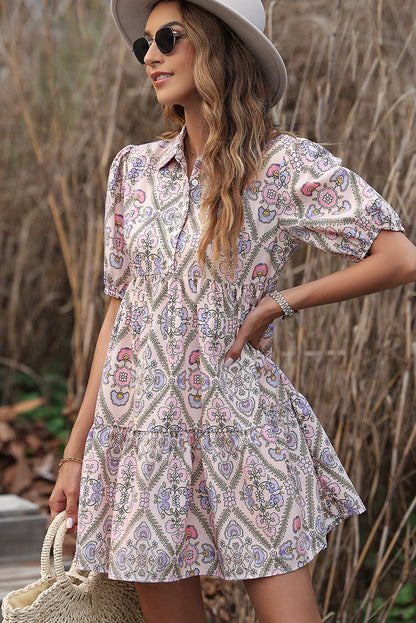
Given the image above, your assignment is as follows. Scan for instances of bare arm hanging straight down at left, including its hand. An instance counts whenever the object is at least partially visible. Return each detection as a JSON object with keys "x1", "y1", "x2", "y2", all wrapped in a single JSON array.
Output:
[{"x1": 49, "y1": 298, "x2": 121, "y2": 527}]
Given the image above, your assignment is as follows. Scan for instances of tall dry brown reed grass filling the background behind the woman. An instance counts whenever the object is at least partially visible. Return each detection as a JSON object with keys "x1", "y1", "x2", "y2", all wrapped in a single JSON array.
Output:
[{"x1": 0, "y1": 0, "x2": 416, "y2": 623}]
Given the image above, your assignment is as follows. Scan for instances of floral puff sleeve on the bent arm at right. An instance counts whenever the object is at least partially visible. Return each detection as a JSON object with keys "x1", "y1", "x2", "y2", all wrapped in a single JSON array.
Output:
[{"x1": 278, "y1": 136, "x2": 404, "y2": 262}]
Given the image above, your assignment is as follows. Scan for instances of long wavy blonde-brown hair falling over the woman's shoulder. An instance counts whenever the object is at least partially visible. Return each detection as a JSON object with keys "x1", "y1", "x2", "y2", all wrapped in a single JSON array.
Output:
[{"x1": 148, "y1": 0, "x2": 282, "y2": 273}]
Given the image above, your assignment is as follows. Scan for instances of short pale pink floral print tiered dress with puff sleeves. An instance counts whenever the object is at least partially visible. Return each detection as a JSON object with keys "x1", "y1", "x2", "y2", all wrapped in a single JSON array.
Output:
[{"x1": 76, "y1": 128, "x2": 402, "y2": 582}]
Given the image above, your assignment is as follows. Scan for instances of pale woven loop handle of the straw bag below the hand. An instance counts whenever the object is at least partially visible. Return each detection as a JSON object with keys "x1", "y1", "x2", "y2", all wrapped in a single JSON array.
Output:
[{"x1": 40, "y1": 511, "x2": 85, "y2": 594}]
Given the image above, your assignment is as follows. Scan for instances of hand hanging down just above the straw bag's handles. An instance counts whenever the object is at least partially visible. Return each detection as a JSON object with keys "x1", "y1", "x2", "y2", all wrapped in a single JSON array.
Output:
[{"x1": 49, "y1": 461, "x2": 82, "y2": 532}]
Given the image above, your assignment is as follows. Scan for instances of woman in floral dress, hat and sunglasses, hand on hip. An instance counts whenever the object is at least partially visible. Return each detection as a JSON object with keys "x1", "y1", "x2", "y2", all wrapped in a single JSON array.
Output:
[{"x1": 50, "y1": 0, "x2": 416, "y2": 623}]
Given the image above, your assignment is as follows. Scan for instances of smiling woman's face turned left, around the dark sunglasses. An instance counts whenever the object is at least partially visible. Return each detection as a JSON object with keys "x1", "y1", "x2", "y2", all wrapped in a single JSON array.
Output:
[{"x1": 144, "y1": 2, "x2": 201, "y2": 111}]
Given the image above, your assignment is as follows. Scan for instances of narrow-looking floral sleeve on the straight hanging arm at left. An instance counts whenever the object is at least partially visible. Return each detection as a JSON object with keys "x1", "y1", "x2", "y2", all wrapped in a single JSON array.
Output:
[{"x1": 104, "y1": 145, "x2": 132, "y2": 299}]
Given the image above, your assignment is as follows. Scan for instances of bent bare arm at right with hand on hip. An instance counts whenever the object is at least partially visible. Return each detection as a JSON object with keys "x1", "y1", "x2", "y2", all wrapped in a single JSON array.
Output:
[{"x1": 226, "y1": 230, "x2": 416, "y2": 365}]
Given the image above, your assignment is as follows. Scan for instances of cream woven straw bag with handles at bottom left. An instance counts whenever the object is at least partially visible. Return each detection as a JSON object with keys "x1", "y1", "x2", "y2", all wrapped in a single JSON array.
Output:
[{"x1": 2, "y1": 511, "x2": 145, "y2": 623}]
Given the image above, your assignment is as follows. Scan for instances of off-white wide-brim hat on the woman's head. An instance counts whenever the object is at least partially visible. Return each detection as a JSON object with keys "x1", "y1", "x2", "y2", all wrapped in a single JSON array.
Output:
[{"x1": 111, "y1": 0, "x2": 287, "y2": 104}]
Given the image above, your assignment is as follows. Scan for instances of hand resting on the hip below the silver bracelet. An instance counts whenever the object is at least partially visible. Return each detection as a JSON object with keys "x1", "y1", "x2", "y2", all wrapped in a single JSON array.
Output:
[{"x1": 224, "y1": 296, "x2": 283, "y2": 368}]
